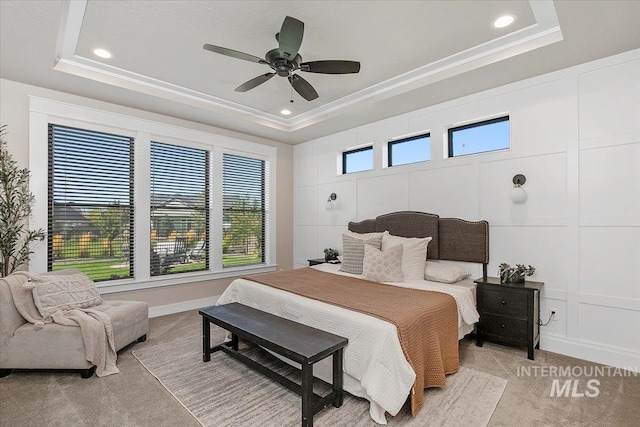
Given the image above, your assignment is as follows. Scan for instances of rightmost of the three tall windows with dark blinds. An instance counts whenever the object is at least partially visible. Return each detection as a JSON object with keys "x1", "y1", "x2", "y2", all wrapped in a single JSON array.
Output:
[{"x1": 222, "y1": 154, "x2": 268, "y2": 268}]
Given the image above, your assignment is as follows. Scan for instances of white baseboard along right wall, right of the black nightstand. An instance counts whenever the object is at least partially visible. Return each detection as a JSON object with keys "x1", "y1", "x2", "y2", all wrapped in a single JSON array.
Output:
[{"x1": 540, "y1": 334, "x2": 640, "y2": 373}]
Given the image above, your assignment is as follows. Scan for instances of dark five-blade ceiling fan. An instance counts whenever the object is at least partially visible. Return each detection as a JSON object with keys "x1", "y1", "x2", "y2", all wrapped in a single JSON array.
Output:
[{"x1": 202, "y1": 16, "x2": 360, "y2": 102}]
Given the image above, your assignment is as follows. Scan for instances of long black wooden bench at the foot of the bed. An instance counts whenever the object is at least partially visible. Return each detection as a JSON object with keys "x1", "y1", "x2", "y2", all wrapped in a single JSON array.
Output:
[{"x1": 200, "y1": 303, "x2": 348, "y2": 427}]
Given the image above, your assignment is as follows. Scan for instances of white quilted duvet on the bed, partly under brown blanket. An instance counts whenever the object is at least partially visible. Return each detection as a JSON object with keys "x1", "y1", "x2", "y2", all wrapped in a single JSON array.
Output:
[{"x1": 218, "y1": 264, "x2": 479, "y2": 424}]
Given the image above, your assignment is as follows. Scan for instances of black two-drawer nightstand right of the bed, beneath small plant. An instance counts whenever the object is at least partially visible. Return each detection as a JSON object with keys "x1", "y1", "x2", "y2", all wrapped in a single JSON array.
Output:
[{"x1": 474, "y1": 277, "x2": 544, "y2": 360}]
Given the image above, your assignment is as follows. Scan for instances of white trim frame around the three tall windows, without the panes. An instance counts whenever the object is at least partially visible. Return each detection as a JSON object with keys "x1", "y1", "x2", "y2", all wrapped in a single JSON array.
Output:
[{"x1": 28, "y1": 97, "x2": 278, "y2": 294}]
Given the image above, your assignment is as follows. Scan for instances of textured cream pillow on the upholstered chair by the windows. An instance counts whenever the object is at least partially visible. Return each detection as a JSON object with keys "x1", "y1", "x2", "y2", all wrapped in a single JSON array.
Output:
[{"x1": 23, "y1": 273, "x2": 102, "y2": 319}]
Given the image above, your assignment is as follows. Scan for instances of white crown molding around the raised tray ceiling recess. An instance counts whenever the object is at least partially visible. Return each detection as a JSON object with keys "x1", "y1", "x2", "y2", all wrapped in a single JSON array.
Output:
[{"x1": 54, "y1": 0, "x2": 563, "y2": 132}]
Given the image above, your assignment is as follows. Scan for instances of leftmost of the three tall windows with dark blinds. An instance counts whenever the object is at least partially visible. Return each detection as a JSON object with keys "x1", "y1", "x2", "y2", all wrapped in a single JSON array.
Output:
[{"x1": 47, "y1": 124, "x2": 134, "y2": 281}]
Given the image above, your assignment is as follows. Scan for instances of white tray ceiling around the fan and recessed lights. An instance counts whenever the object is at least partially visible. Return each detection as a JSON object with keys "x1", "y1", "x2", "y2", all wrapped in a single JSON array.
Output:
[{"x1": 0, "y1": 0, "x2": 640, "y2": 143}]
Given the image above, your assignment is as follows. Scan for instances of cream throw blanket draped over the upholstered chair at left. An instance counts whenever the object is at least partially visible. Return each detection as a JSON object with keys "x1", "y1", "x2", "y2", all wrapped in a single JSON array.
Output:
[{"x1": 4, "y1": 271, "x2": 120, "y2": 377}]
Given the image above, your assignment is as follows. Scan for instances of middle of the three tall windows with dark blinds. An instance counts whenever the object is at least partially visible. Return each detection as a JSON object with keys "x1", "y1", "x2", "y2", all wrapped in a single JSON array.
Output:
[{"x1": 150, "y1": 142, "x2": 209, "y2": 276}]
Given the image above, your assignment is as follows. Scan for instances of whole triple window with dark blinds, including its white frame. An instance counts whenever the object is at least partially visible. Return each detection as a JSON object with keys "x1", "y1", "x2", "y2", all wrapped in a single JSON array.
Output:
[{"x1": 29, "y1": 98, "x2": 277, "y2": 294}]
